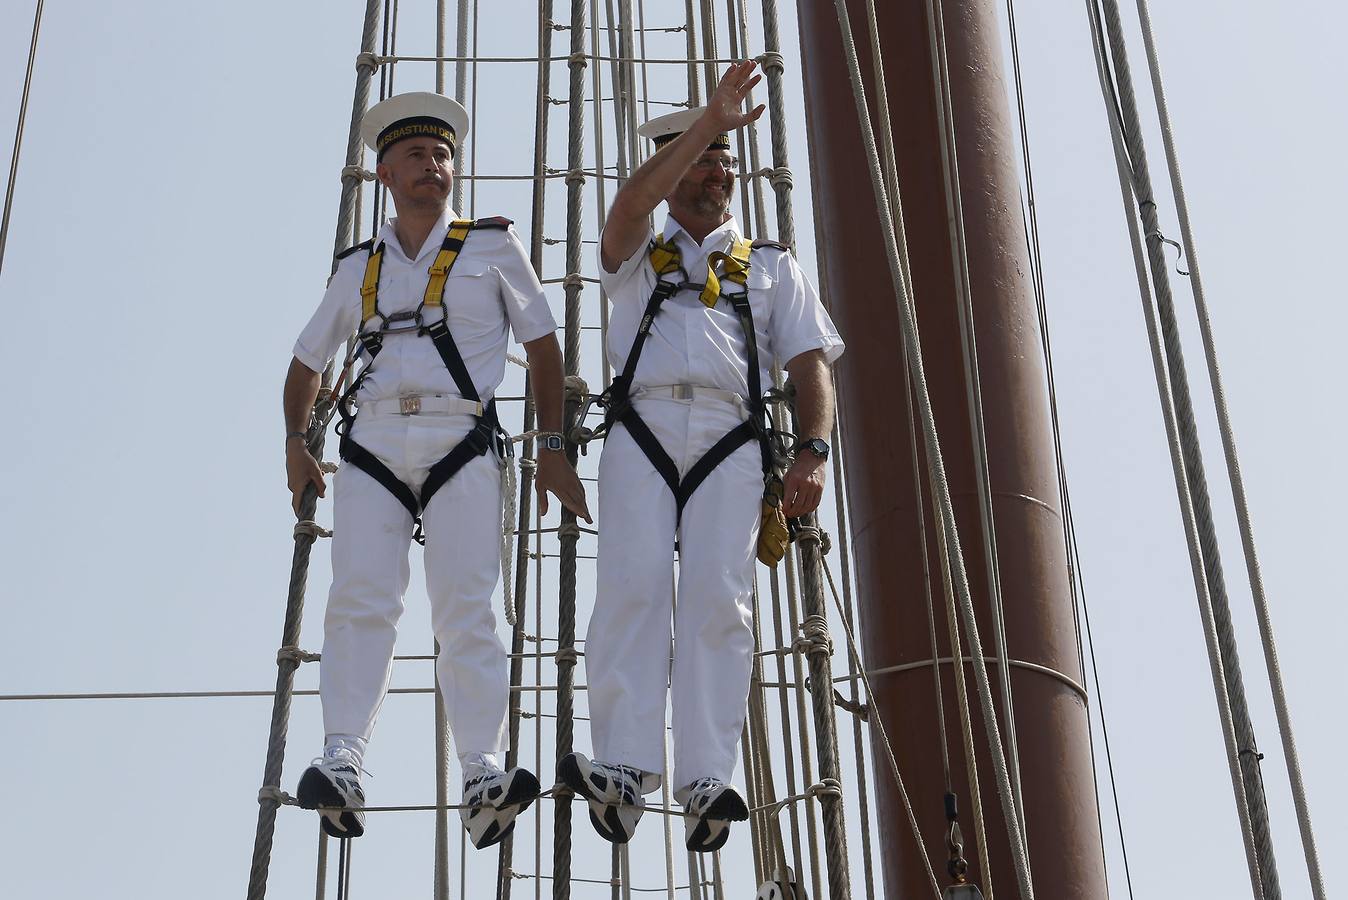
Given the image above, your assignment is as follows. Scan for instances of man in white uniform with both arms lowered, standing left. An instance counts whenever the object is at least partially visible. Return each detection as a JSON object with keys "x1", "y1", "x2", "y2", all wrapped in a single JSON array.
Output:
[{"x1": 284, "y1": 93, "x2": 589, "y2": 846}]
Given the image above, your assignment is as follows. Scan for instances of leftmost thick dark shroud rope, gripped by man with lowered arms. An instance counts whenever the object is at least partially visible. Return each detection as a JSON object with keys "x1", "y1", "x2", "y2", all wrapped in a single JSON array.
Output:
[{"x1": 248, "y1": 0, "x2": 379, "y2": 900}]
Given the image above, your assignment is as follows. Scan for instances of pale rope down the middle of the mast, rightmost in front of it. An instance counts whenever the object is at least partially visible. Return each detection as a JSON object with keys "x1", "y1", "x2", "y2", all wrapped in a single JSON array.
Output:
[{"x1": 927, "y1": 0, "x2": 1030, "y2": 851}]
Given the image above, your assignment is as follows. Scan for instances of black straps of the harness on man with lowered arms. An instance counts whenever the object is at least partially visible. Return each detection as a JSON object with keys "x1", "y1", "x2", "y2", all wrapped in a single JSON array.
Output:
[{"x1": 337, "y1": 218, "x2": 510, "y2": 543}]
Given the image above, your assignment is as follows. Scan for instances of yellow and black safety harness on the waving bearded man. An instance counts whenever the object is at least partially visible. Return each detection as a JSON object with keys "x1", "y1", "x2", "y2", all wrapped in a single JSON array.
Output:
[{"x1": 599, "y1": 237, "x2": 786, "y2": 520}]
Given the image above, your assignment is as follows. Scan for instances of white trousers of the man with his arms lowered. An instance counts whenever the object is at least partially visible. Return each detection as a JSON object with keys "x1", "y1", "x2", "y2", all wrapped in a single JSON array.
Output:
[{"x1": 319, "y1": 415, "x2": 510, "y2": 754}]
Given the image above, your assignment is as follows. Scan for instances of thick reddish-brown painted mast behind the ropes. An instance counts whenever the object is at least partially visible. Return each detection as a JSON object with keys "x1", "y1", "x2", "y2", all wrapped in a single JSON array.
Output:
[{"x1": 798, "y1": 0, "x2": 1107, "y2": 900}]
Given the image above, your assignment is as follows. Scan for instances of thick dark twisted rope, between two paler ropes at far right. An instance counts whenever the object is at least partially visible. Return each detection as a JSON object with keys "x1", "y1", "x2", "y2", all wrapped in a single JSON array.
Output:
[{"x1": 1104, "y1": 0, "x2": 1281, "y2": 900}]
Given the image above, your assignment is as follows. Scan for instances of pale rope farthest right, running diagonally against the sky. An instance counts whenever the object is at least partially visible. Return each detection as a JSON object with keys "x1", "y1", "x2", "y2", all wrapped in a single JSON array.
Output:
[{"x1": 1136, "y1": 0, "x2": 1325, "y2": 900}]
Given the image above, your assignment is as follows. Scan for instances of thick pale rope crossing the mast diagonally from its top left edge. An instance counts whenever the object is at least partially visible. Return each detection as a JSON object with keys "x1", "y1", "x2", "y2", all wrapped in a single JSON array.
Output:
[{"x1": 834, "y1": 0, "x2": 1034, "y2": 900}]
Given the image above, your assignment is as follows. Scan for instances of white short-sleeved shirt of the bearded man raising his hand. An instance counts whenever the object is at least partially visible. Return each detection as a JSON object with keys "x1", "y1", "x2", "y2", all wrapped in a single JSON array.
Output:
[{"x1": 599, "y1": 217, "x2": 844, "y2": 396}]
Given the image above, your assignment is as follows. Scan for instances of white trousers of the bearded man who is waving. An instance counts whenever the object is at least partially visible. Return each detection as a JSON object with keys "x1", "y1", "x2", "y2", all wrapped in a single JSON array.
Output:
[{"x1": 585, "y1": 399, "x2": 763, "y2": 790}]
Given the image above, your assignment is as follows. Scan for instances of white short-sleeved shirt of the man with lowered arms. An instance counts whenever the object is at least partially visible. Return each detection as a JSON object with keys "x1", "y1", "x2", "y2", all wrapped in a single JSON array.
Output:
[{"x1": 295, "y1": 210, "x2": 557, "y2": 403}]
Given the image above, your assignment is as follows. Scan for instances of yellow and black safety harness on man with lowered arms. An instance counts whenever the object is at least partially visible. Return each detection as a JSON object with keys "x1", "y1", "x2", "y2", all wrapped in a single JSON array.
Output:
[{"x1": 337, "y1": 218, "x2": 511, "y2": 543}]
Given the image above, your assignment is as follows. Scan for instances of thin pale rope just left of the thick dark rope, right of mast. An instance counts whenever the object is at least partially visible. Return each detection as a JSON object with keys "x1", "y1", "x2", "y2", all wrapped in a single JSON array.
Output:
[{"x1": 1086, "y1": 0, "x2": 1263, "y2": 899}]
